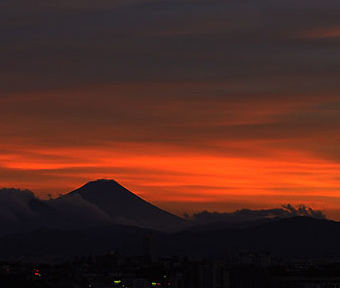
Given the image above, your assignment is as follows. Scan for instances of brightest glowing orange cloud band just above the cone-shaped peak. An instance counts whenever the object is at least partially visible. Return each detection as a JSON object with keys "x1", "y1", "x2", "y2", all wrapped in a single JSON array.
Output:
[{"x1": 0, "y1": 143, "x2": 340, "y2": 218}]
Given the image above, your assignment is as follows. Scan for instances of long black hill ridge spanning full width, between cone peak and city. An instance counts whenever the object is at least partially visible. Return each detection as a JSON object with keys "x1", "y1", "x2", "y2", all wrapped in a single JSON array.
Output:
[{"x1": 0, "y1": 217, "x2": 340, "y2": 258}]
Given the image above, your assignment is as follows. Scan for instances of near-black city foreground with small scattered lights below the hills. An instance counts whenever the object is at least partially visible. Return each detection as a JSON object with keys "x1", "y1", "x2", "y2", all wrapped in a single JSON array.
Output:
[{"x1": 0, "y1": 252, "x2": 340, "y2": 288}]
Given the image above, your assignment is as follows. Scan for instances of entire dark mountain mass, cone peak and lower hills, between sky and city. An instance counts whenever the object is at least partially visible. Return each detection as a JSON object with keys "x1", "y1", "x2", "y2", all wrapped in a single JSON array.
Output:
[{"x1": 0, "y1": 180, "x2": 340, "y2": 258}]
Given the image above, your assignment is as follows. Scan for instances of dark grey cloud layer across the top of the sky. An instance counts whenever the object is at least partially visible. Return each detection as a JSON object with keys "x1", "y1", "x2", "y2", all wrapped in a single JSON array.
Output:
[{"x1": 1, "y1": 0, "x2": 339, "y2": 89}]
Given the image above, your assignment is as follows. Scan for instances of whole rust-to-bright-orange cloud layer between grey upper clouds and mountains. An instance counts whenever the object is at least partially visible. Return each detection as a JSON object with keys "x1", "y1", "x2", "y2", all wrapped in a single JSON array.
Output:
[{"x1": 0, "y1": 81, "x2": 340, "y2": 219}]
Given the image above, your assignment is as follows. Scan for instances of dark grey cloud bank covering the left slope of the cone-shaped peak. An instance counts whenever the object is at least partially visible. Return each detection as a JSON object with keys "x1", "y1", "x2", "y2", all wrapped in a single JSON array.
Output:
[{"x1": 0, "y1": 188, "x2": 112, "y2": 235}]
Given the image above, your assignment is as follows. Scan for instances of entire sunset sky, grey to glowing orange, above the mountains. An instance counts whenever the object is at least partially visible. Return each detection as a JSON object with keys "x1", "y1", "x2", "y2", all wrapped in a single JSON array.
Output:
[{"x1": 0, "y1": 0, "x2": 340, "y2": 220}]
